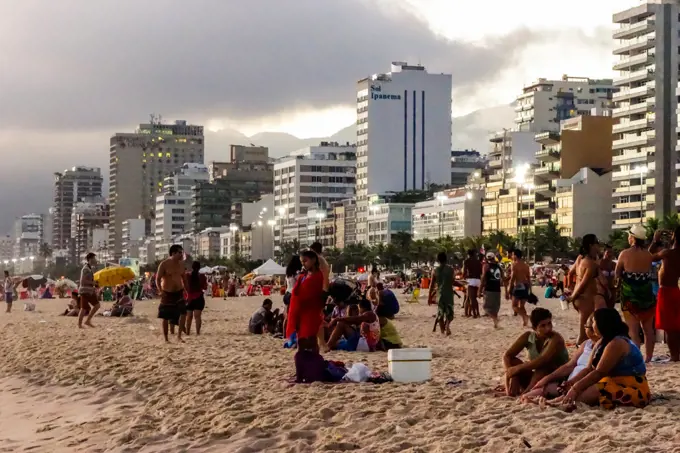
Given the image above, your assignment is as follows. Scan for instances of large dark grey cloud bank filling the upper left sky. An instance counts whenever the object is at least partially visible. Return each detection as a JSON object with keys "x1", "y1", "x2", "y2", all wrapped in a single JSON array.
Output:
[{"x1": 0, "y1": 0, "x2": 536, "y2": 129}]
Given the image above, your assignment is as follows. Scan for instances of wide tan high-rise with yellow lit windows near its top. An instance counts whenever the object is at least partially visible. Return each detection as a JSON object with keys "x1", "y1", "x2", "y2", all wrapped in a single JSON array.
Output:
[{"x1": 109, "y1": 118, "x2": 204, "y2": 257}]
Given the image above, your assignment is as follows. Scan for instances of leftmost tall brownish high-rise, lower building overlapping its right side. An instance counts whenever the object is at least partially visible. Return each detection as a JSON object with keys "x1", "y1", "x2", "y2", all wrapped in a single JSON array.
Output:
[{"x1": 50, "y1": 166, "x2": 104, "y2": 252}]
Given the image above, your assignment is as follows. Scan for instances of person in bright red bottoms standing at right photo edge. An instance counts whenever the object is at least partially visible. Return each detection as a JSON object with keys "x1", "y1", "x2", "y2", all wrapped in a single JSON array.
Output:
[{"x1": 649, "y1": 227, "x2": 680, "y2": 362}]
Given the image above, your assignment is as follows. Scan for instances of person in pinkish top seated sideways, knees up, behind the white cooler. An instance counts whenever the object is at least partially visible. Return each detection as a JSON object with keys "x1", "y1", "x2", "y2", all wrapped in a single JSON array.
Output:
[{"x1": 326, "y1": 299, "x2": 380, "y2": 352}]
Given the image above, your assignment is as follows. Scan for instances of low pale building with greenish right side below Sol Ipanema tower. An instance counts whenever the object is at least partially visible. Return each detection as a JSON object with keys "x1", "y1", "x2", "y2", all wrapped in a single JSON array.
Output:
[{"x1": 366, "y1": 195, "x2": 414, "y2": 246}]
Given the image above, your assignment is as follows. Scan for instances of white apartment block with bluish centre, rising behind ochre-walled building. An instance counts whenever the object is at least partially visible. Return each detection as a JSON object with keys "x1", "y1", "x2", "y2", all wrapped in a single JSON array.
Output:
[{"x1": 515, "y1": 75, "x2": 615, "y2": 132}]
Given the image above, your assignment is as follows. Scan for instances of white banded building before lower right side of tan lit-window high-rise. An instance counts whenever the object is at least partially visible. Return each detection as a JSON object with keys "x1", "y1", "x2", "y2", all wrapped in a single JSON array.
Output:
[{"x1": 153, "y1": 190, "x2": 193, "y2": 259}]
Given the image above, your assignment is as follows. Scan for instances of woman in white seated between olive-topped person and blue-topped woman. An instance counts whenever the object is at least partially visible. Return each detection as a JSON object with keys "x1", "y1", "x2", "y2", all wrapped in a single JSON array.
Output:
[{"x1": 522, "y1": 315, "x2": 600, "y2": 402}]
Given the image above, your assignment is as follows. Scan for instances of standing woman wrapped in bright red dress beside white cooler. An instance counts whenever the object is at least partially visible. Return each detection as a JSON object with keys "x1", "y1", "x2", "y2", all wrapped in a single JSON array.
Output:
[{"x1": 286, "y1": 250, "x2": 324, "y2": 350}]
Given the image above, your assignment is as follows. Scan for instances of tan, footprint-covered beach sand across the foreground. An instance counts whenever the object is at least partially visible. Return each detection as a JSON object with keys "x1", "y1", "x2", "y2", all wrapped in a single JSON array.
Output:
[{"x1": 0, "y1": 296, "x2": 680, "y2": 453}]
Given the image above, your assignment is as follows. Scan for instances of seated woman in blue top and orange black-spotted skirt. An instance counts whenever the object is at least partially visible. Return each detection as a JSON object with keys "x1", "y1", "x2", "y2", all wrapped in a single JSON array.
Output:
[{"x1": 551, "y1": 308, "x2": 651, "y2": 409}]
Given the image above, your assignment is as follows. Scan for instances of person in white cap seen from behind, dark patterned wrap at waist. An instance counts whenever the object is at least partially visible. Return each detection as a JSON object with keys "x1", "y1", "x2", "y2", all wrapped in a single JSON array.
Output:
[{"x1": 616, "y1": 225, "x2": 656, "y2": 362}]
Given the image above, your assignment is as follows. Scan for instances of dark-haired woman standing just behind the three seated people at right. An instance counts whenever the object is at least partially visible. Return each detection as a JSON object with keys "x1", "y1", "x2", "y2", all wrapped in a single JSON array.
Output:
[{"x1": 569, "y1": 234, "x2": 607, "y2": 345}]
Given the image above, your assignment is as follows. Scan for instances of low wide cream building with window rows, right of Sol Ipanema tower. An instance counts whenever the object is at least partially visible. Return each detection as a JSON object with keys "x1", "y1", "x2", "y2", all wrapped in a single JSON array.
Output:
[{"x1": 411, "y1": 189, "x2": 484, "y2": 240}]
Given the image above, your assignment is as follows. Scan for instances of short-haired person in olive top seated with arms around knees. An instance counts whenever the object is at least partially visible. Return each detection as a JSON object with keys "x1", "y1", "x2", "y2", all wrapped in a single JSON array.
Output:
[{"x1": 503, "y1": 308, "x2": 569, "y2": 396}]
